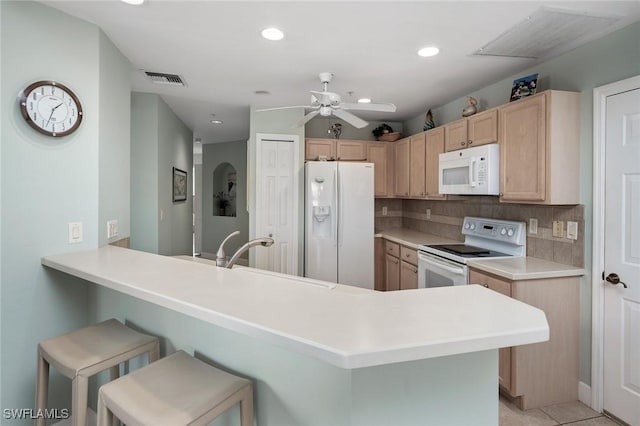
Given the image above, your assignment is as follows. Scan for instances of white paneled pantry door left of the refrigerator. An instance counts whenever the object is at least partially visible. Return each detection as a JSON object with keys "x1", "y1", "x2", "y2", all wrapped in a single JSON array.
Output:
[{"x1": 254, "y1": 135, "x2": 298, "y2": 275}]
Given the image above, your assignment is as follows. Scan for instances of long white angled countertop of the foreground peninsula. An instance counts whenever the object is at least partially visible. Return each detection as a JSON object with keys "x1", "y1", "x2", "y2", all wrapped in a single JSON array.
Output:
[{"x1": 42, "y1": 246, "x2": 549, "y2": 368}]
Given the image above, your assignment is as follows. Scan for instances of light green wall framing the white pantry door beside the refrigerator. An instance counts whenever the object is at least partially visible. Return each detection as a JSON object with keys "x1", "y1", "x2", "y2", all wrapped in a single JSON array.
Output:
[{"x1": 247, "y1": 107, "x2": 305, "y2": 275}]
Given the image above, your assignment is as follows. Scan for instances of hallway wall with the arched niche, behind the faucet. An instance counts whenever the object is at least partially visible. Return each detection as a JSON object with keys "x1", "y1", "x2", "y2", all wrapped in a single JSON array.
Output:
[{"x1": 202, "y1": 141, "x2": 249, "y2": 256}]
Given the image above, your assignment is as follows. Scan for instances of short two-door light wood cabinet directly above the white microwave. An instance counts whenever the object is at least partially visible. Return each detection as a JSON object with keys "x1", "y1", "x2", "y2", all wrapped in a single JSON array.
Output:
[{"x1": 444, "y1": 108, "x2": 498, "y2": 151}]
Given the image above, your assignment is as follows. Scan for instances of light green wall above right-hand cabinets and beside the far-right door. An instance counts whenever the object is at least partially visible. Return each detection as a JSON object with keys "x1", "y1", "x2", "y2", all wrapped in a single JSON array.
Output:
[{"x1": 404, "y1": 23, "x2": 640, "y2": 384}]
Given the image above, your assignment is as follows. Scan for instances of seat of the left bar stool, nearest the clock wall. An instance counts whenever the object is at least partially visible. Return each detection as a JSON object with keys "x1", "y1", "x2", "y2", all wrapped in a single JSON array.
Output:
[{"x1": 38, "y1": 319, "x2": 158, "y2": 378}]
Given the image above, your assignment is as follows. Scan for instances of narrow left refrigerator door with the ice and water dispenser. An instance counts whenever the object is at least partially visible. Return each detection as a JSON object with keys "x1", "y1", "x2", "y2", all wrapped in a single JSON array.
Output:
[{"x1": 304, "y1": 161, "x2": 338, "y2": 283}]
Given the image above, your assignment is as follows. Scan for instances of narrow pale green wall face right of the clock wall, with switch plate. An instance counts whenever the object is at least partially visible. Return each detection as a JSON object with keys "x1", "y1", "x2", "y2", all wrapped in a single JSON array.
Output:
[{"x1": 98, "y1": 32, "x2": 131, "y2": 246}]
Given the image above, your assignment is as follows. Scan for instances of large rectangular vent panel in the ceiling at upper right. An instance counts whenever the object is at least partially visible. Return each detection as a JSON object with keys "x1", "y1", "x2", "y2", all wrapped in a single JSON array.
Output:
[{"x1": 474, "y1": 7, "x2": 620, "y2": 59}]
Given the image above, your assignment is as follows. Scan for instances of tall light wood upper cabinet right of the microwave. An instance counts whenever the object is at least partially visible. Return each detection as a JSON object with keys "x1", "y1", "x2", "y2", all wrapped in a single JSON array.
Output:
[{"x1": 499, "y1": 90, "x2": 580, "y2": 204}]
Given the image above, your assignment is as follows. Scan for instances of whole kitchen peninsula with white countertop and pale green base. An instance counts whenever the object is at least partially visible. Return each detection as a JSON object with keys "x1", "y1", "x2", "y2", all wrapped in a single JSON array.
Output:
[{"x1": 42, "y1": 246, "x2": 549, "y2": 426}]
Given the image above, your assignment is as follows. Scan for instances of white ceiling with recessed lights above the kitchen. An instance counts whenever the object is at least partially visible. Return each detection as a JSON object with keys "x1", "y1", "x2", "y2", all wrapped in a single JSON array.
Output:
[{"x1": 41, "y1": 0, "x2": 640, "y2": 143}]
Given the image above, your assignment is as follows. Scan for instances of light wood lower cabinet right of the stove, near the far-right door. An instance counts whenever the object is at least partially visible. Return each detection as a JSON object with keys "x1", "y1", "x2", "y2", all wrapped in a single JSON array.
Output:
[{"x1": 469, "y1": 269, "x2": 579, "y2": 410}]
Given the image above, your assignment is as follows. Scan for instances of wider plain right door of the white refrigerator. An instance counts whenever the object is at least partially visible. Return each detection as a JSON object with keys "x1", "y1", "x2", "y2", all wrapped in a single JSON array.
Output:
[{"x1": 338, "y1": 162, "x2": 374, "y2": 289}]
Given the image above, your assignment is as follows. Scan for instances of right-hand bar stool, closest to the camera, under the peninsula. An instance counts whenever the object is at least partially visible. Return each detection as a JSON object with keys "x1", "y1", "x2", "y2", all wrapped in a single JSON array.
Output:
[{"x1": 98, "y1": 351, "x2": 253, "y2": 426}]
